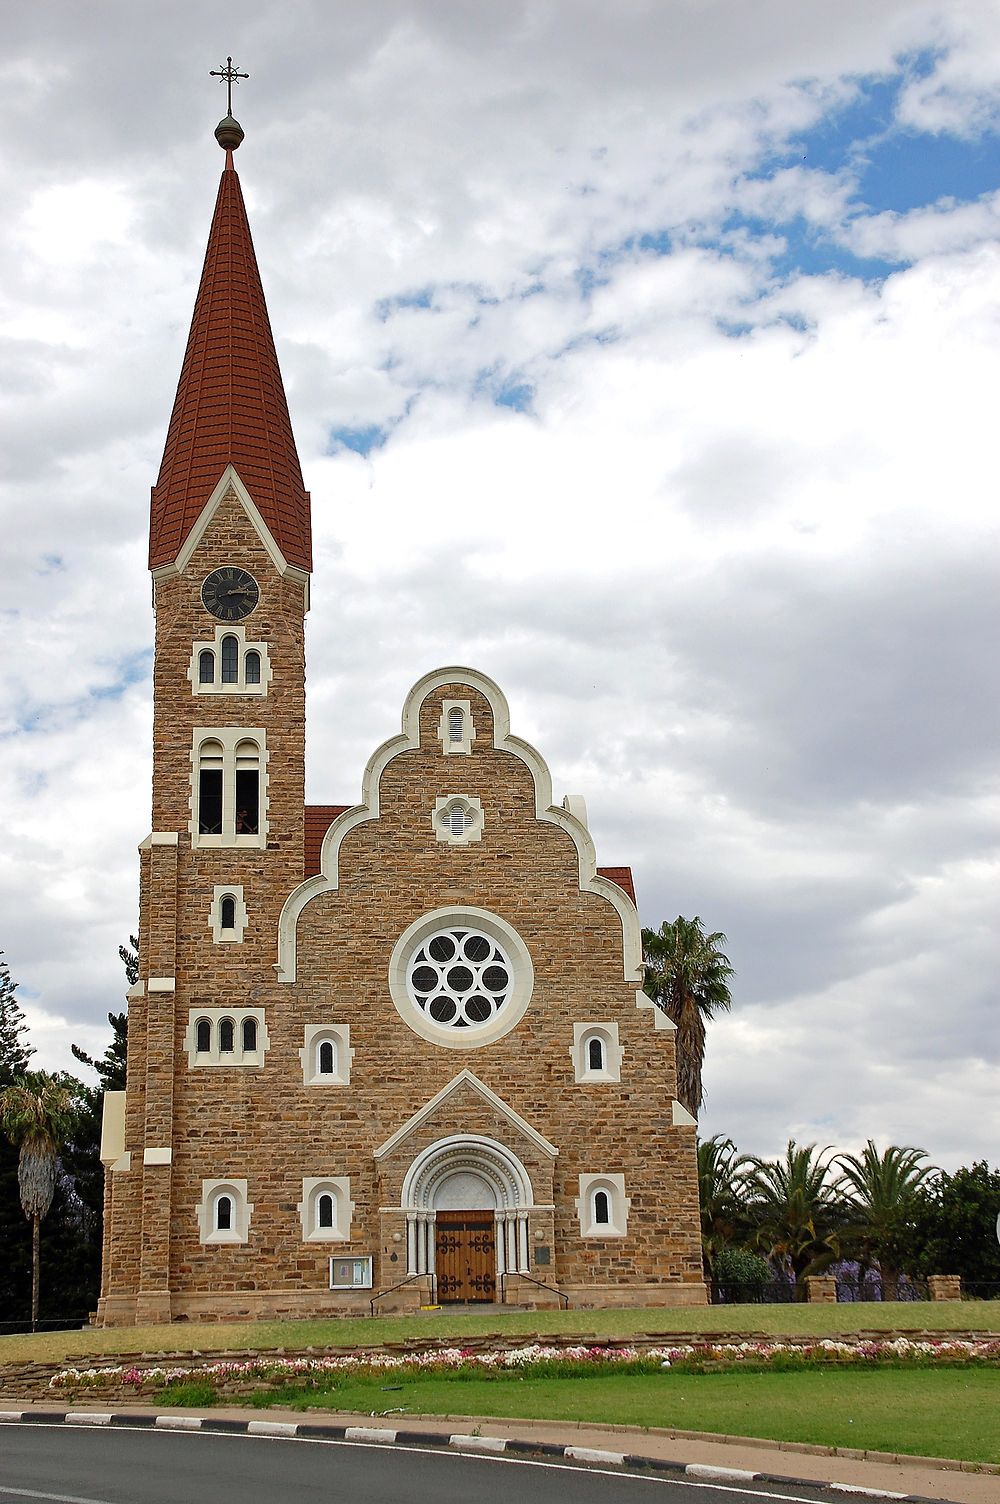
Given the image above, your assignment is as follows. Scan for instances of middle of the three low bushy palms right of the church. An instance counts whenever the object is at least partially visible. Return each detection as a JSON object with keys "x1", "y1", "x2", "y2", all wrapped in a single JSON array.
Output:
[{"x1": 746, "y1": 1139, "x2": 844, "y2": 1283}]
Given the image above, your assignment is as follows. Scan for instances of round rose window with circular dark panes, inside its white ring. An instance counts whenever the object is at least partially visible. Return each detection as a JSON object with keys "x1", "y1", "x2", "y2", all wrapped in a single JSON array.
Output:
[{"x1": 406, "y1": 929, "x2": 513, "y2": 1029}]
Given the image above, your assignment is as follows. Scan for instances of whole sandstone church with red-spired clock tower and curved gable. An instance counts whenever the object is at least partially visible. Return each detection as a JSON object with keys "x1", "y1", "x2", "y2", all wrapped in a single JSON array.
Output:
[{"x1": 98, "y1": 114, "x2": 705, "y2": 1325}]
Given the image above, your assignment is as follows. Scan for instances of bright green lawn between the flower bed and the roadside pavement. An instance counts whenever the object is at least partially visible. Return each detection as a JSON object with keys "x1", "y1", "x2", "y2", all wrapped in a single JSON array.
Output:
[{"x1": 256, "y1": 1369, "x2": 1000, "y2": 1462}]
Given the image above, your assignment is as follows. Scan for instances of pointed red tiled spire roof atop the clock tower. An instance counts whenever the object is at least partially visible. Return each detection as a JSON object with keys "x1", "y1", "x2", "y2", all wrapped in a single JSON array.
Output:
[{"x1": 149, "y1": 150, "x2": 313, "y2": 570}]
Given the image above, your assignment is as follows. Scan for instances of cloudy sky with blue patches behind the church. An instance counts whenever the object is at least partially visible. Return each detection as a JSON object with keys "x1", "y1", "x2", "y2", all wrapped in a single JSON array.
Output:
[{"x1": 0, "y1": 0, "x2": 1000, "y2": 1169}]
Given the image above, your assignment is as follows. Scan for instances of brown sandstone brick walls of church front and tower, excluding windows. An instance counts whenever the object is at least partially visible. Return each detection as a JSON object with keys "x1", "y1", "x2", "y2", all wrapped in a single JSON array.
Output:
[{"x1": 102, "y1": 504, "x2": 705, "y2": 1321}]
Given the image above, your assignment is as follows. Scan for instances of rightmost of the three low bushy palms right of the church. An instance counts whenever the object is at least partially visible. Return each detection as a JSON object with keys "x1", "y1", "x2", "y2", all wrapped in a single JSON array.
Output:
[{"x1": 836, "y1": 1139, "x2": 934, "y2": 1301}]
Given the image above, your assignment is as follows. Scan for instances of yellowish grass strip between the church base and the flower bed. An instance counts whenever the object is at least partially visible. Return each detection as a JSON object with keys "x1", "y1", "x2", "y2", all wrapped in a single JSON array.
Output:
[{"x1": 0, "y1": 1301, "x2": 1000, "y2": 1364}]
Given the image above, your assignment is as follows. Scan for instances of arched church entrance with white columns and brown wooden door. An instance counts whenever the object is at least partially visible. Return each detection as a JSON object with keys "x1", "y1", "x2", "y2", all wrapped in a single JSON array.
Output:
[{"x1": 402, "y1": 1134, "x2": 534, "y2": 1304}]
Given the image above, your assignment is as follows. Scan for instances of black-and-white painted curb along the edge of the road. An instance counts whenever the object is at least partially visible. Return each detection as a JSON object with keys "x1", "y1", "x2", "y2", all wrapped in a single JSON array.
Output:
[{"x1": 0, "y1": 1409, "x2": 940, "y2": 1504}]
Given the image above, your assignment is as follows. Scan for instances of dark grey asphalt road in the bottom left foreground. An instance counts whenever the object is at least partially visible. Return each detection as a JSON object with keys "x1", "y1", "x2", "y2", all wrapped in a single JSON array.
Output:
[{"x1": 0, "y1": 1424, "x2": 830, "y2": 1504}]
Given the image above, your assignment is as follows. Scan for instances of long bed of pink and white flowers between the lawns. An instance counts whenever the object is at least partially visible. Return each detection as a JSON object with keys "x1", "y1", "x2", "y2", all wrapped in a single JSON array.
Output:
[{"x1": 50, "y1": 1337, "x2": 1000, "y2": 1394}]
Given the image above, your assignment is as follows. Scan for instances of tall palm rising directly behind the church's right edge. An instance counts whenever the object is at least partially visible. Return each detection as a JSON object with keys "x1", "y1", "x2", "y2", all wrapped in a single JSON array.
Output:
[{"x1": 642, "y1": 914, "x2": 734, "y2": 1117}]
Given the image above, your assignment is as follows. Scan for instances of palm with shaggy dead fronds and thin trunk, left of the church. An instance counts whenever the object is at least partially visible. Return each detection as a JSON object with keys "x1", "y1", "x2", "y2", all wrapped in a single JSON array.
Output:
[{"x1": 0, "y1": 1071, "x2": 72, "y2": 1331}]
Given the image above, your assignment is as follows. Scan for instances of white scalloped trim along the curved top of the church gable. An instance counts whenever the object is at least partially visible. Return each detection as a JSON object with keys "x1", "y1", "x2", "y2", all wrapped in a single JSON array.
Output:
[{"x1": 276, "y1": 668, "x2": 643, "y2": 992}]
